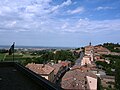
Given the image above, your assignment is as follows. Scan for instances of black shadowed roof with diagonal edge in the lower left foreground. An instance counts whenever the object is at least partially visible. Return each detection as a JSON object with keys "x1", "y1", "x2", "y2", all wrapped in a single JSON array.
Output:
[{"x1": 0, "y1": 62, "x2": 62, "y2": 90}]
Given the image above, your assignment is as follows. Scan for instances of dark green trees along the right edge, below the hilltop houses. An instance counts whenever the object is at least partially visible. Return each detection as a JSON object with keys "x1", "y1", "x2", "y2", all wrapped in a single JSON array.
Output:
[{"x1": 96, "y1": 55, "x2": 120, "y2": 90}]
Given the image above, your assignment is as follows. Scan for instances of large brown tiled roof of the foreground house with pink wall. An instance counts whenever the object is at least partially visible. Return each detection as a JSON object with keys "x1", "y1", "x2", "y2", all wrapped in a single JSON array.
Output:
[{"x1": 61, "y1": 69, "x2": 97, "y2": 90}]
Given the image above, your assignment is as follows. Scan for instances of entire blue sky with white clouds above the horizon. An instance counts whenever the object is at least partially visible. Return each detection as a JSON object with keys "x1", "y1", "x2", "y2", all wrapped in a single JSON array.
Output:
[{"x1": 0, "y1": 0, "x2": 120, "y2": 47}]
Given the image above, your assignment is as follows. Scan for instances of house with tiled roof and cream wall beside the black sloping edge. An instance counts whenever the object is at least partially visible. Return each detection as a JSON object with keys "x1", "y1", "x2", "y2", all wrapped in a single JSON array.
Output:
[{"x1": 26, "y1": 63, "x2": 54, "y2": 82}]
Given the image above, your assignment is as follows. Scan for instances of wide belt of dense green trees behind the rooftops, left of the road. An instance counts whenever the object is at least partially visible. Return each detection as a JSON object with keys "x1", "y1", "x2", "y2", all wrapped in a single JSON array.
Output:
[{"x1": 22, "y1": 50, "x2": 78, "y2": 65}]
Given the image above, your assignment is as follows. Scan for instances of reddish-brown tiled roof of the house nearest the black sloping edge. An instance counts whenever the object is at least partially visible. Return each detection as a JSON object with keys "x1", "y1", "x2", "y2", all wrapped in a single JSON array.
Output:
[{"x1": 26, "y1": 63, "x2": 54, "y2": 75}]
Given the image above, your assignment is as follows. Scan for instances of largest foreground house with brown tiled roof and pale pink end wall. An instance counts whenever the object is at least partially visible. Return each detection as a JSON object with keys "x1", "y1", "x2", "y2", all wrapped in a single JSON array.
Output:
[{"x1": 61, "y1": 69, "x2": 97, "y2": 90}]
